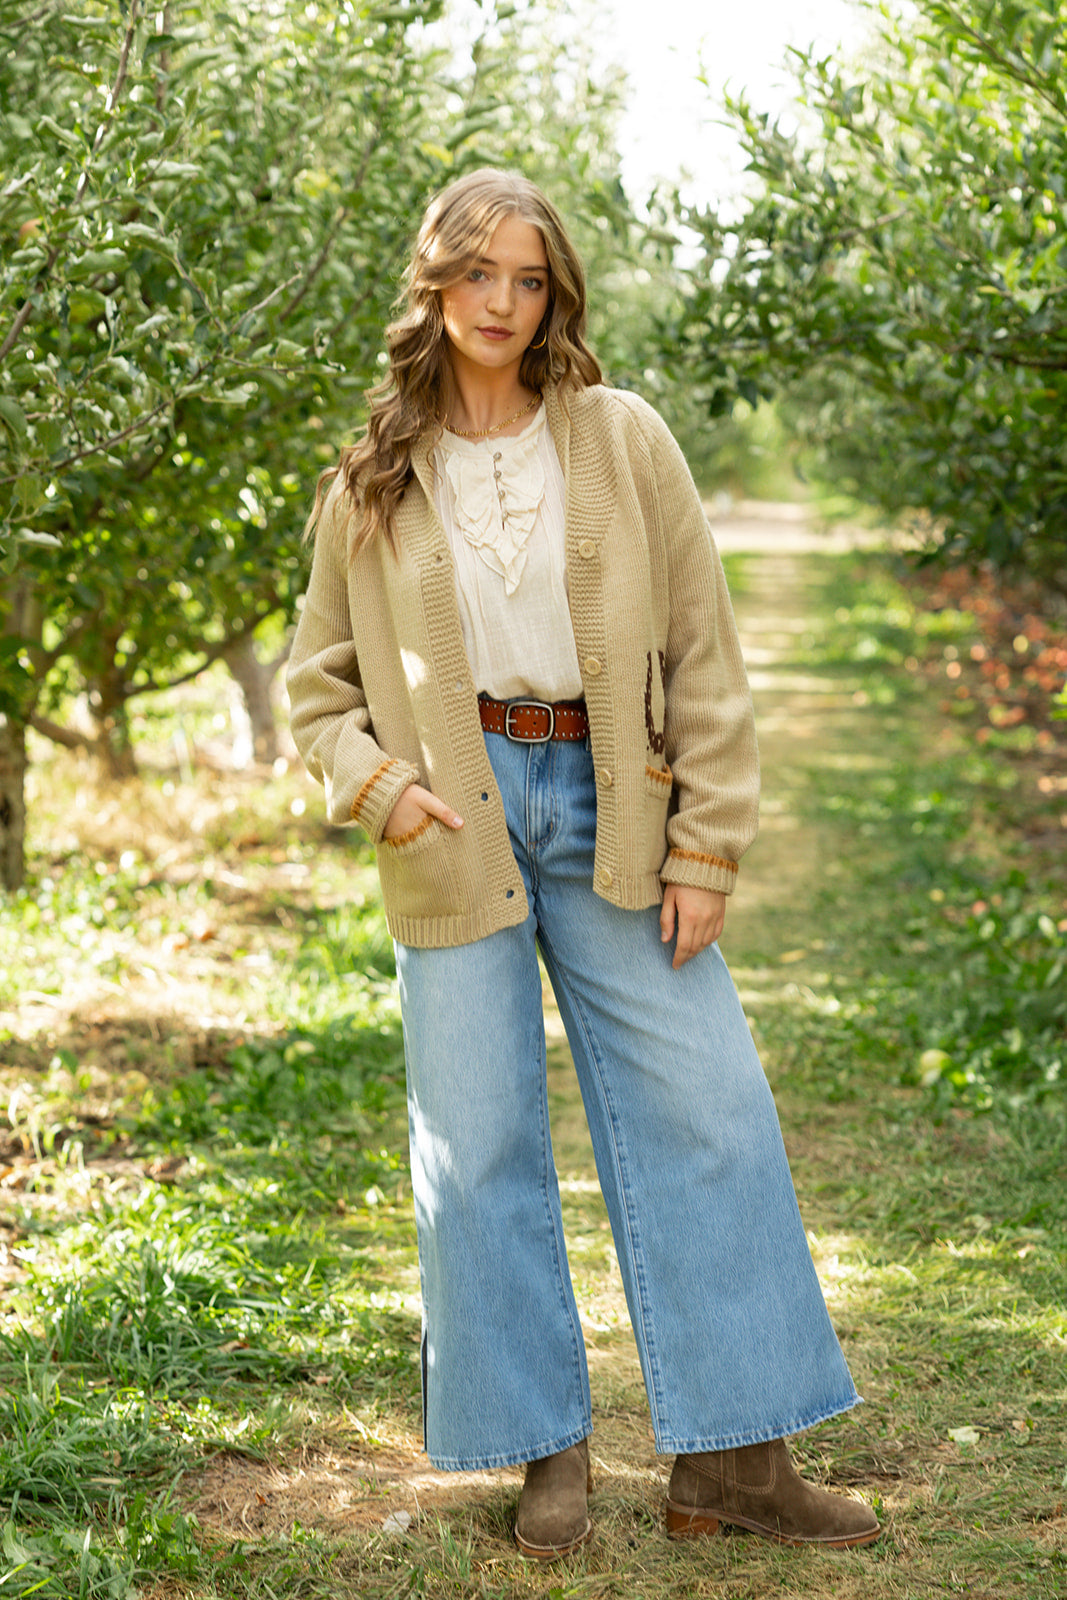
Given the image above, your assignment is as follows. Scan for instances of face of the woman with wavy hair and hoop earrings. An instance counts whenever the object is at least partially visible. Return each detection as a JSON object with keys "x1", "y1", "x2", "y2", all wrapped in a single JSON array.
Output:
[{"x1": 442, "y1": 216, "x2": 549, "y2": 374}]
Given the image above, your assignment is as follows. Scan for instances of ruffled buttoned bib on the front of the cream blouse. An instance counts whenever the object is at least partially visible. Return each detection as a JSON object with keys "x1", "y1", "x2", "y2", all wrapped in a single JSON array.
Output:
[{"x1": 438, "y1": 411, "x2": 545, "y2": 595}]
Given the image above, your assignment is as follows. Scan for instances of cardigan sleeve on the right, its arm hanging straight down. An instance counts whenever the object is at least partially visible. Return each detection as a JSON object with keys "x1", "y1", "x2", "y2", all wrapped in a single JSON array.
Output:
[{"x1": 643, "y1": 408, "x2": 760, "y2": 893}]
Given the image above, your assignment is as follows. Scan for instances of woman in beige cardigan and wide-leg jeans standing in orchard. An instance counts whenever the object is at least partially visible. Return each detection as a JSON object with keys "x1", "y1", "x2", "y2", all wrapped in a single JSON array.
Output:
[{"x1": 288, "y1": 168, "x2": 878, "y2": 1560}]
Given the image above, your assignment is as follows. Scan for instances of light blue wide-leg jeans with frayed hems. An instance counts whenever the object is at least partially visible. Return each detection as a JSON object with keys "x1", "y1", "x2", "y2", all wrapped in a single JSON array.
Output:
[{"x1": 397, "y1": 734, "x2": 857, "y2": 1470}]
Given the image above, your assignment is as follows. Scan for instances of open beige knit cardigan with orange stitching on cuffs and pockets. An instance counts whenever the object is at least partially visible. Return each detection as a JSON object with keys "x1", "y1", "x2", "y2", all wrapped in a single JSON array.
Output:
[{"x1": 288, "y1": 386, "x2": 760, "y2": 946}]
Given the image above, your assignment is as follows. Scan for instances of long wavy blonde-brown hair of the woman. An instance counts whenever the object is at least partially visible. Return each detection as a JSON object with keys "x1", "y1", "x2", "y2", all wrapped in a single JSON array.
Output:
[{"x1": 304, "y1": 166, "x2": 601, "y2": 555}]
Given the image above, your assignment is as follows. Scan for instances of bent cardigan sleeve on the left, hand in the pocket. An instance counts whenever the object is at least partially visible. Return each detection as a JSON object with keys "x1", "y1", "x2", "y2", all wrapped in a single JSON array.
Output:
[{"x1": 286, "y1": 490, "x2": 419, "y2": 843}]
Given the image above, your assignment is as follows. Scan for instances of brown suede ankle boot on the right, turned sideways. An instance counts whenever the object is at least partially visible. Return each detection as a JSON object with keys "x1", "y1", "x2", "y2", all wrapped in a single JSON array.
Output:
[{"x1": 667, "y1": 1438, "x2": 881, "y2": 1550}]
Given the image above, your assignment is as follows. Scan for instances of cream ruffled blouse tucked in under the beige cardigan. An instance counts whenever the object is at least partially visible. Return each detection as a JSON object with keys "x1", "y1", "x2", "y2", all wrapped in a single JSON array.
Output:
[{"x1": 434, "y1": 408, "x2": 582, "y2": 701}]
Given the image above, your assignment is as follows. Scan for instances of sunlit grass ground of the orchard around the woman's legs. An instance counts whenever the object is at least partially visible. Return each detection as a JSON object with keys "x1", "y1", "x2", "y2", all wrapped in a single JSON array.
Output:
[{"x1": 0, "y1": 544, "x2": 1067, "y2": 1600}]
